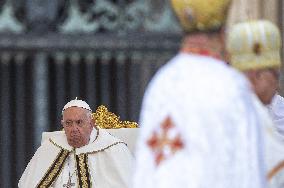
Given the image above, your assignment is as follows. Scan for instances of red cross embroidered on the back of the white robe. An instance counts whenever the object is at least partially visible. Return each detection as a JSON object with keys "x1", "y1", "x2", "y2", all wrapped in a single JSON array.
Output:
[{"x1": 147, "y1": 116, "x2": 184, "y2": 166}]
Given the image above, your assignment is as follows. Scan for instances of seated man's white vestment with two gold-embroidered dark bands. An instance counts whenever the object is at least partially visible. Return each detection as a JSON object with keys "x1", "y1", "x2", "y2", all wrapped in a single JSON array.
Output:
[{"x1": 18, "y1": 129, "x2": 133, "y2": 188}]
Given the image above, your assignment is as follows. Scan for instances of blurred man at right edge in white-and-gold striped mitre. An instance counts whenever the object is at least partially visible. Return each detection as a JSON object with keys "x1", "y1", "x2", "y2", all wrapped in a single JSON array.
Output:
[{"x1": 227, "y1": 20, "x2": 284, "y2": 188}]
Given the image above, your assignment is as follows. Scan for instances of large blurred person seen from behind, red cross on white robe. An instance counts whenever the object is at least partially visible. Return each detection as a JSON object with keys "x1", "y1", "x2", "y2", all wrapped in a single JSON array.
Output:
[{"x1": 133, "y1": 0, "x2": 266, "y2": 188}]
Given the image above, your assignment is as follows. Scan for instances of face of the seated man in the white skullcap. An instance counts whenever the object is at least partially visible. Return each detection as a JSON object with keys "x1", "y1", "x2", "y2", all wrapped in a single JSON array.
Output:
[{"x1": 61, "y1": 107, "x2": 93, "y2": 148}]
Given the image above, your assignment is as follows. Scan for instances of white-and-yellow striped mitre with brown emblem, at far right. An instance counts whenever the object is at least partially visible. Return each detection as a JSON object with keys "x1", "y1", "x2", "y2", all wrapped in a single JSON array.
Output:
[{"x1": 226, "y1": 20, "x2": 281, "y2": 70}]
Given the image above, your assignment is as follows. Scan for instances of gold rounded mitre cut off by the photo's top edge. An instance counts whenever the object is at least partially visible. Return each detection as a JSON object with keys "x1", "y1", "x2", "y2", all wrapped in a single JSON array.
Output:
[{"x1": 171, "y1": 0, "x2": 230, "y2": 32}]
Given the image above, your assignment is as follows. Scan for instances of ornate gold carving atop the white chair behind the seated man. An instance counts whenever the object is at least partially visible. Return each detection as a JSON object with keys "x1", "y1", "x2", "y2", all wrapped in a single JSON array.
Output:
[{"x1": 92, "y1": 105, "x2": 138, "y2": 129}]
